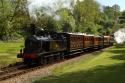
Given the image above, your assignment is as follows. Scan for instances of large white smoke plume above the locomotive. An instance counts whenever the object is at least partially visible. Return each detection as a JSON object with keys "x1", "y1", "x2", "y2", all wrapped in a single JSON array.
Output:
[{"x1": 28, "y1": 0, "x2": 84, "y2": 20}]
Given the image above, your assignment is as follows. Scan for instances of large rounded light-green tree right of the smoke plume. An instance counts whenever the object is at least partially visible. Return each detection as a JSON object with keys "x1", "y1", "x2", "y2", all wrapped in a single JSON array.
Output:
[{"x1": 73, "y1": 0, "x2": 100, "y2": 33}]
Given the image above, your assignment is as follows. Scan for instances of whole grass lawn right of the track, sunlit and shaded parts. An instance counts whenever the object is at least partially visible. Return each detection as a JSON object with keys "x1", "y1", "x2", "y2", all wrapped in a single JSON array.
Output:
[{"x1": 34, "y1": 47, "x2": 125, "y2": 83}]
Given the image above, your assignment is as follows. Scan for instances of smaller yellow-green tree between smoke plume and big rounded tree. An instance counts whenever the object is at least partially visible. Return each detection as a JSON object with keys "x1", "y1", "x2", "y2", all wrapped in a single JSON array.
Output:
[{"x1": 57, "y1": 9, "x2": 76, "y2": 32}]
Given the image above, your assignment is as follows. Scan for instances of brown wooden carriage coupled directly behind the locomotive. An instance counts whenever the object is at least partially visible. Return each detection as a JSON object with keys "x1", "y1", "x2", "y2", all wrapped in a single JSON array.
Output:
[{"x1": 63, "y1": 33, "x2": 83, "y2": 55}]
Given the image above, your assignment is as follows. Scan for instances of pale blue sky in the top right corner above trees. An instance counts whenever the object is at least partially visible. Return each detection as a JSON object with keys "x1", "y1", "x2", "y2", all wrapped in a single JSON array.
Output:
[{"x1": 97, "y1": 0, "x2": 125, "y2": 11}]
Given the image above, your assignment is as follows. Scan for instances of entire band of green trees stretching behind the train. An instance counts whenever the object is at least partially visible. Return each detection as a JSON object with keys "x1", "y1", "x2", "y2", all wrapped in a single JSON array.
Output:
[{"x1": 0, "y1": 0, "x2": 124, "y2": 39}]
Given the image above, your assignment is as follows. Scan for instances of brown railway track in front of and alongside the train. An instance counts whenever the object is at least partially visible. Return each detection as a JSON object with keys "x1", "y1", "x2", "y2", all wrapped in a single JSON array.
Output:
[{"x1": 0, "y1": 47, "x2": 110, "y2": 81}]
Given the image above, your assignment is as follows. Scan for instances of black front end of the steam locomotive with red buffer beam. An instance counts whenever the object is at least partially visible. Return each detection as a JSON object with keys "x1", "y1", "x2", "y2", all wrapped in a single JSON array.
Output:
[{"x1": 23, "y1": 35, "x2": 50, "y2": 64}]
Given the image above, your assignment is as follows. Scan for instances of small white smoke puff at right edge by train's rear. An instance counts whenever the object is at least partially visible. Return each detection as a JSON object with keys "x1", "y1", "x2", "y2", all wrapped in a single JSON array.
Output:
[{"x1": 114, "y1": 29, "x2": 125, "y2": 44}]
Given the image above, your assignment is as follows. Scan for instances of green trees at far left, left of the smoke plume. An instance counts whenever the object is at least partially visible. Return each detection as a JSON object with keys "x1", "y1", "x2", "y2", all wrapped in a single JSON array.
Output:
[{"x1": 0, "y1": 0, "x2": 29, "y2": 39}]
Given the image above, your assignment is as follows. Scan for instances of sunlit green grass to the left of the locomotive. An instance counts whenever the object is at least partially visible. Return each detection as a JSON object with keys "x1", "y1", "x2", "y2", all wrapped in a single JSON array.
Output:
[{"x1": 0, "y1": 39, "x2": 23, "y2": 67}]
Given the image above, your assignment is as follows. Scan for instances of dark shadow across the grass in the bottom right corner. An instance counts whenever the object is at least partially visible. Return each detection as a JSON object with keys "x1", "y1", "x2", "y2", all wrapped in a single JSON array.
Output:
[{"x1": 34, "y1": 63, "x2": 125, "y2": 83}]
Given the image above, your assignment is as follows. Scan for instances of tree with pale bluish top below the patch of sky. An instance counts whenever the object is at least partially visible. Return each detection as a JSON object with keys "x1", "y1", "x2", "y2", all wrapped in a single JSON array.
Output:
[{"x1": 102, "y1": 4, "x2": 121, "y2": 35}]
